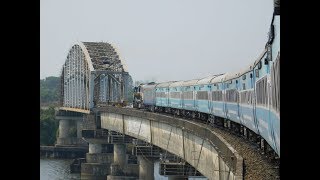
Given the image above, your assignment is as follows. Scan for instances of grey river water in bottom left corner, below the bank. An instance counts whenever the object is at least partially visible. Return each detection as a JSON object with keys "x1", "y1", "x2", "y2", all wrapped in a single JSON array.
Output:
[{"x1": 40, "y1": 159, "x2": 80, "y2": 180}]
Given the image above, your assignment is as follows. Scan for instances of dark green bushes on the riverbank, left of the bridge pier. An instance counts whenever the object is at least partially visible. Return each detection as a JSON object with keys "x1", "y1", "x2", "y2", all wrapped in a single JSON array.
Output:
[{"x1": 40, "y1": 106, "x2": 59, "y2": 145}]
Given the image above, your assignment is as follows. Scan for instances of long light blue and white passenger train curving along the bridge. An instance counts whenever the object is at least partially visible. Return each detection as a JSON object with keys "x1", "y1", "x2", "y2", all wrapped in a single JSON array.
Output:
[{"x1": 134, "y1": 7, "x2": 280, "y2": 158}]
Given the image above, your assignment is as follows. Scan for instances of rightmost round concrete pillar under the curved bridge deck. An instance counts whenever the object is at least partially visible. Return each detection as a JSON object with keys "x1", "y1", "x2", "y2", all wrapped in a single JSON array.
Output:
[{"x1": 138, "y1": 156, "x2": 154, "y2": 180}]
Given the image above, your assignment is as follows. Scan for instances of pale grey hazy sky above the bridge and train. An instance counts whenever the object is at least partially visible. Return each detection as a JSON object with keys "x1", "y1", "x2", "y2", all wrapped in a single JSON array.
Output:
[{"x1": 40, "y1": 0, "x2": 273, "y2": 82}]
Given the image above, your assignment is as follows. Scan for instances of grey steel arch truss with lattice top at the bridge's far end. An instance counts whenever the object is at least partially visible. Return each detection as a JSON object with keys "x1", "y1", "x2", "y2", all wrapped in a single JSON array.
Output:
[{"x1": 60, "y1": 42, "x2": 132, "y2": 113}]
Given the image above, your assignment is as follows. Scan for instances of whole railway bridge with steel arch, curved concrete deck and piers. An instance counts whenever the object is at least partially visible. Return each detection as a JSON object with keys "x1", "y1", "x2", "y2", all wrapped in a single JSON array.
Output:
[{"x1": 56, "y1": 0, "x2": 280, "y2": 177}]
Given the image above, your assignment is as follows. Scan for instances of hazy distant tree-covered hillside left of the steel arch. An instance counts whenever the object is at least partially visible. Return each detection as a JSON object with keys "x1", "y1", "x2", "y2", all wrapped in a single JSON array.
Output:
[{"x1": 40, "y1": 76, "x2": 60, "y2": 106}]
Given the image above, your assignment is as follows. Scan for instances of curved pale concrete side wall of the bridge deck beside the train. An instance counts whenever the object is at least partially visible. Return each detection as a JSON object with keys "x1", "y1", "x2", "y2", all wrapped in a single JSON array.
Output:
[{"x1": 94, "y1": 106, "x2": 243, "y2": 179}]
